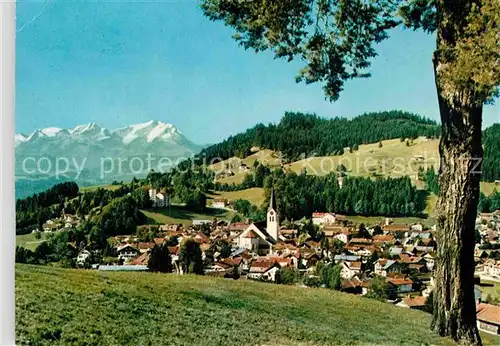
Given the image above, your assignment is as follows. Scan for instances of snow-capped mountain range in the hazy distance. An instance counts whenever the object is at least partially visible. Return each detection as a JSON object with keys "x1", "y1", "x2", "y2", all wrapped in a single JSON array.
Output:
[{"x1": 15, "y1": 120, "x2": 202, "y2": 197}]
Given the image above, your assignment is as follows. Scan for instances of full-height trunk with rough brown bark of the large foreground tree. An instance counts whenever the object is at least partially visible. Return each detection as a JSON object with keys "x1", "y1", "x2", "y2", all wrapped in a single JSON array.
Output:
[{"x1": 432, "y1": 0, "x2": 483, "y2": 345}]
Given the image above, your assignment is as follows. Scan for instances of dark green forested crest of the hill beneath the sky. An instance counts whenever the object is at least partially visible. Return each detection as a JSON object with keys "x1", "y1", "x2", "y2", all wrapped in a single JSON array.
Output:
[{"x1": 200, "y1": 110, "x2": 440, "y2": 160}]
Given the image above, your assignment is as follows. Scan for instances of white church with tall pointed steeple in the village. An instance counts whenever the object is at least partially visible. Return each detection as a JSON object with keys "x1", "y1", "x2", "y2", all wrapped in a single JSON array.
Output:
[{"x1": 236, "y1": 189, "x2": 282, "y2": 256}]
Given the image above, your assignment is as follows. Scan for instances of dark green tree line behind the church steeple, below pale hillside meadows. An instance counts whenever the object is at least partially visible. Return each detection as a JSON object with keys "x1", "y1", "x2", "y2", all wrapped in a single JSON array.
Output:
[{"x1": 265, "y1": 170, "x2": 427, "y2": 220}]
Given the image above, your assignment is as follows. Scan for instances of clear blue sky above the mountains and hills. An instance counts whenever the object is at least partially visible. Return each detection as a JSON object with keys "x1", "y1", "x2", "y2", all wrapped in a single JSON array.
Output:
[{"x1": 16, "y1": 0, "x2": 500, "y2": 144}]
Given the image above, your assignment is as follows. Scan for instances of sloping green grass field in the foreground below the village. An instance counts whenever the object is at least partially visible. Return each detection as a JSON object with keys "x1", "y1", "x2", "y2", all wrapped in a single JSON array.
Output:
[{"x1": 16, "y1": 265, "x2": 500, "y2": 345}]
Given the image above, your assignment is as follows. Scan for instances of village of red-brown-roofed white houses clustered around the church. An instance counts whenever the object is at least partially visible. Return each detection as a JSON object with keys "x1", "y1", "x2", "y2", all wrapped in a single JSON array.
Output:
[{"x1": 33, "y1": 190, "x2": 500, "y2": 334}]
